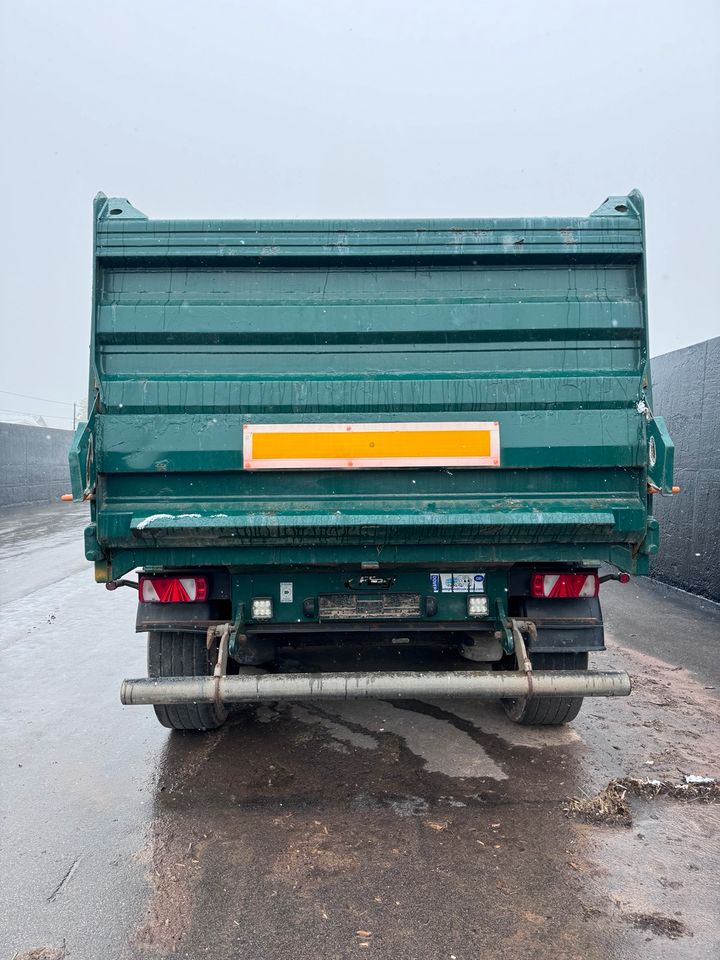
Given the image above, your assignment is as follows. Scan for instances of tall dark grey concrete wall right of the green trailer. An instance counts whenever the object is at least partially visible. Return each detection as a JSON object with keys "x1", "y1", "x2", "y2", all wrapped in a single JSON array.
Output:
[{"x1": 651, "y1": 337, "x2": 720, "y2": 601}]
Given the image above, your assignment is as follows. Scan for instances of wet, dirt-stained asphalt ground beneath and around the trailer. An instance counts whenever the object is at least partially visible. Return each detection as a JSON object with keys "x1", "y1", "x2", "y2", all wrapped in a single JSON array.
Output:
[{"x1": 0, "y1": 504, "x2": 720, "y2": 960}]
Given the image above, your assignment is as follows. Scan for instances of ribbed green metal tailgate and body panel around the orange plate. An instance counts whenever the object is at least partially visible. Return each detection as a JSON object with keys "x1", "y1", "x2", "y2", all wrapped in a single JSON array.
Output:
[{"x1": 71, "y1": 192, "x2": 672, "y2": 576}]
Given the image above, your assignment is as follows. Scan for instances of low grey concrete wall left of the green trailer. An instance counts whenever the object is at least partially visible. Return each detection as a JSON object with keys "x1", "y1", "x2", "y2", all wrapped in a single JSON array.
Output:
[{"x1": 0, "y1": 423, "x2": 73, "y2": 507}]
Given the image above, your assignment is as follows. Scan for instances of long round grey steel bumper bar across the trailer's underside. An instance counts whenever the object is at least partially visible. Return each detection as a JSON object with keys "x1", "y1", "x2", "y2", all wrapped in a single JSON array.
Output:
[{"x1": 120, "y1": 670, "x2": 630, "y2": 704}]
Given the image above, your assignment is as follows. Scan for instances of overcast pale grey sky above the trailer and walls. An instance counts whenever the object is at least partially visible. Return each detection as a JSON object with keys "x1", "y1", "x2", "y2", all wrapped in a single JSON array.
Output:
[{"x1": 0, "y1": 0, "x2": 720, "y2": 426}]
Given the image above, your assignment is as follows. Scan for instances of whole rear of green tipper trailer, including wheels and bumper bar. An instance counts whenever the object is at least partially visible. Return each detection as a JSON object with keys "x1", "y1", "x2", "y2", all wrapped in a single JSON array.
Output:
[{"x1": 70, "y1": 191, "x2": 677, "y2": 730}]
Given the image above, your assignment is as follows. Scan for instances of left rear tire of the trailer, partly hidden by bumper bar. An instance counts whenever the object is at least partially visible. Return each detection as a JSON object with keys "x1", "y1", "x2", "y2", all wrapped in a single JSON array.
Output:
[{"x1": 148, "y1": 630, "x2": 228, "y2": 730}]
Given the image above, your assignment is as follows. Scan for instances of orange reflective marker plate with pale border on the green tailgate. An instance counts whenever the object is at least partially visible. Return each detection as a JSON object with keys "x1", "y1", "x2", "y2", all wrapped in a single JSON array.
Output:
[{"x1": 243, "y1": 421, "x2": 500, "y2": 470}]
